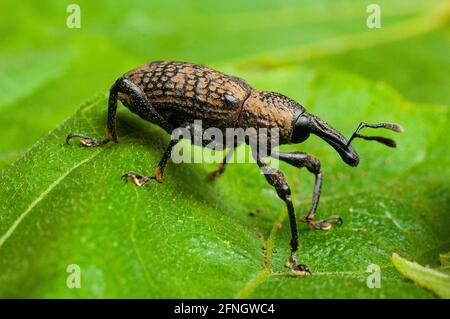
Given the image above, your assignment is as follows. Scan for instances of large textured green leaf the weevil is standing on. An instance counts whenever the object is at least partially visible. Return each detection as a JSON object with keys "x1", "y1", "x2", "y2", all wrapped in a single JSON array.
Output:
[{"x1": 0, "y1": 67, "x2": 450, "y2": 298}]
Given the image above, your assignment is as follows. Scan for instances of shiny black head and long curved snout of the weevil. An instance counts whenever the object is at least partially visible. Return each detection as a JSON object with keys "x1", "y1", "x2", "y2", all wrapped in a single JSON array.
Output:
[{"x1": 291, "y1": 111, "x2": 359, "y2": 166}]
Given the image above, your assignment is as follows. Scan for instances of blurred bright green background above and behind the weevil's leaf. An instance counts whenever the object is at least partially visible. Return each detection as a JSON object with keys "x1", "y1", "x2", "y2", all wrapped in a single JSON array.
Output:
[{"x1": 0, "y1": 0, "x2": 450, "y2": 165}]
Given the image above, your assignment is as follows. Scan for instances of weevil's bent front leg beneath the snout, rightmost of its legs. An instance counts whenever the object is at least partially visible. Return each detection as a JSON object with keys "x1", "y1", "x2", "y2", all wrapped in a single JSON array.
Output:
[{"x1": 271, "y1": 152, "x2": 343, "y2": 230}]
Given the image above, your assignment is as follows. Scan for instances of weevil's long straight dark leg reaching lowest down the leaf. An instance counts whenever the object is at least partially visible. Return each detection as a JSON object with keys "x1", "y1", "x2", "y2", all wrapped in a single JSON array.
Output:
[{"x1": 256, "y1": 156, "x2": 311, "y2": 275}]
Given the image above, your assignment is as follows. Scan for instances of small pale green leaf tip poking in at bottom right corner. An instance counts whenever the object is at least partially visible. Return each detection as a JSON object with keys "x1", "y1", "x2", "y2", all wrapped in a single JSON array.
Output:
[{"x1": 392, "y1": 253, "x2": 450, "y2": 299}]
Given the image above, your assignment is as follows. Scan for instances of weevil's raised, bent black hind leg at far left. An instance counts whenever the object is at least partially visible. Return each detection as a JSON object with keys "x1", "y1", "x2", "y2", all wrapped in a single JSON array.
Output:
[{"x1": 66, "y1": 78, "x2": 172, "y2": 147}]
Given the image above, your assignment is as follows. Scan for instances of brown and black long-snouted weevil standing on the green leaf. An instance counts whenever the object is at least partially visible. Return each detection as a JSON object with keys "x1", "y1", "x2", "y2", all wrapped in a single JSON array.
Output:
[{"x1": 66, "y1": 61, "x2": 403, "y2": 275}]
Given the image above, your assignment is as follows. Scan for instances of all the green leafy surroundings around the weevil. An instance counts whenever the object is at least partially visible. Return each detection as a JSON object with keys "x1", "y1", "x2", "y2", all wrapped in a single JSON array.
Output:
[{"x1": 0, "y1": 0, "x2": 450, "y2": 298}]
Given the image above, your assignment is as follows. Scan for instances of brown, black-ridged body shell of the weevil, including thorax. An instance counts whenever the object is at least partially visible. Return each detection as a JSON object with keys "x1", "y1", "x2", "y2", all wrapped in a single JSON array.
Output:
[{"x1": 119, "y1": 61, "x2": 303, "y2": 143}]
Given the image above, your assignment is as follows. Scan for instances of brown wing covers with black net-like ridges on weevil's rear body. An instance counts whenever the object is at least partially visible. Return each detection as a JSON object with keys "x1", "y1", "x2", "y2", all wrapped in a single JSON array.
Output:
[{"x1": 125, "y1": 61, "x2": 252, "y2": 125}]
